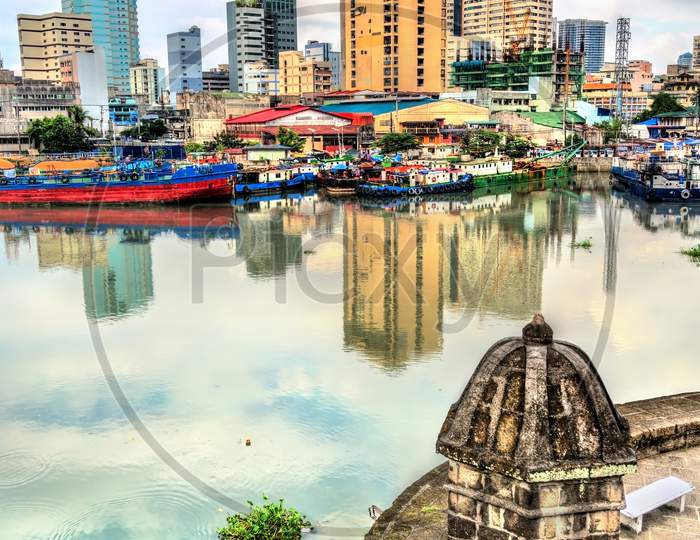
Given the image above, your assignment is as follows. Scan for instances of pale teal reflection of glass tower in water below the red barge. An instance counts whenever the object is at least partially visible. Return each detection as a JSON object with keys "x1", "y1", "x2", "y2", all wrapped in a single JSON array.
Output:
[{"x1": 83, "y1": 231, "x2": 153, "y2": 320}]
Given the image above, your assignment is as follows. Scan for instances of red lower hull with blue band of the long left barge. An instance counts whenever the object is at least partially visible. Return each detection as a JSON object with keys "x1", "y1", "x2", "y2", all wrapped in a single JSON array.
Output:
[{"x1": 0, "y1": 176, "x2": 232, "y2": 205}]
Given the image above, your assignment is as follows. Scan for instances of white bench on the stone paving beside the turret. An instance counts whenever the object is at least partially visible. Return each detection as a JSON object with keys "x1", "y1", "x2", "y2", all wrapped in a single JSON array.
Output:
[{"x1": 621, "y1": 476, "x2": 695, "y2": 534}]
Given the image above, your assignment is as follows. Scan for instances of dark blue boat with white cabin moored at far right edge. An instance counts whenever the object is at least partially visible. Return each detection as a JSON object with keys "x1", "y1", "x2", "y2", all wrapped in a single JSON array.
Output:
[{"x1": 611, "y1": 156, "x2": 700, "y2": 202}]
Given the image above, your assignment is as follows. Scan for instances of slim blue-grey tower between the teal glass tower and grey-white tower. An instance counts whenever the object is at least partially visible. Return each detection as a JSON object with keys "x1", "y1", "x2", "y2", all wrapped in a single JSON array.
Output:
[{"x1": 168, "y1": 26, "x2": 202, "y2": 99}]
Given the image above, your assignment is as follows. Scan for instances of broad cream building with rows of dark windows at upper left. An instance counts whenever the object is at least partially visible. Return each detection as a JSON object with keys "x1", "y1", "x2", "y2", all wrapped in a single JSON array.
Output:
[{"x1": 17, "y1": 13, "x2": 93, "y2": 82}]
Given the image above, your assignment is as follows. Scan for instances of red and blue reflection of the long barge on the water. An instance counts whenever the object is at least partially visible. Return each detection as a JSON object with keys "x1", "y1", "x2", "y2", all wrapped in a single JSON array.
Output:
[{"x1": 0, "y1": 205, "x2": 237, "y2": 238}]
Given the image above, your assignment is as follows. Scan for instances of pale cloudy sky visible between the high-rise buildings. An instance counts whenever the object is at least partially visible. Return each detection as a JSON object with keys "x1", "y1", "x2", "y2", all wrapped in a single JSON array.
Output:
[{"x1": 0, "y1": 0, "x2": 700, "y2": 73}]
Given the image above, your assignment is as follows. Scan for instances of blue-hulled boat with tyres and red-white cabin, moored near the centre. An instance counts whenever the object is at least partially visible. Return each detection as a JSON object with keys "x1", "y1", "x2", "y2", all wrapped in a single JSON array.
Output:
[{"x1": 357, "y1": 166, "x2": 474, "y2": 197}]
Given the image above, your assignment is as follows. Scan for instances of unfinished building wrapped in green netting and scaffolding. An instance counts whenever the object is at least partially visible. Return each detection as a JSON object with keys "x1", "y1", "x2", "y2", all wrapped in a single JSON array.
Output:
[{"x1": 451, "y1": 49, "x2": 585, "y2": 105}]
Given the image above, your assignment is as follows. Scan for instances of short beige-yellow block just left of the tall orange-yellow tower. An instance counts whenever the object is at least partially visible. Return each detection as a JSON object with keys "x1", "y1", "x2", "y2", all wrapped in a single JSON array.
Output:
[{"x1": 279, "y1": 51, "x2": 333, "y2": 96}]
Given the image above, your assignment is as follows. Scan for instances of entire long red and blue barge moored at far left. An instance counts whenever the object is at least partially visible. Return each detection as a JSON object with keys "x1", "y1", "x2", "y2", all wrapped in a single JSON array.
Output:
[{"x1": 0, "y1": 163, "x2": 237, "y2": 204}]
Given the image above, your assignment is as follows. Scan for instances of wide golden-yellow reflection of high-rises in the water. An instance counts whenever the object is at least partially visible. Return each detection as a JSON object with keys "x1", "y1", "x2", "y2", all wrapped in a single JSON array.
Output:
[{"x1": 343, "y1": 192, "x2": 576, "y2": 370}]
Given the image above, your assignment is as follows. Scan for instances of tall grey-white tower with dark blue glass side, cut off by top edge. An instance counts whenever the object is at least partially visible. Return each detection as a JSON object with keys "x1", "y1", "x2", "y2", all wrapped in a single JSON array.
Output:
[{"x1": 226, "y1": 0, "x2": 297, "y2": 91}]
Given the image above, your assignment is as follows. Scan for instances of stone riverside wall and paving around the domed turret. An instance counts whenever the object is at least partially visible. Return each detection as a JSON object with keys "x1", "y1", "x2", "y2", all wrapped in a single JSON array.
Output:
[{"x1": 365, "y1": 392, "x2": 700, "y2": 540}]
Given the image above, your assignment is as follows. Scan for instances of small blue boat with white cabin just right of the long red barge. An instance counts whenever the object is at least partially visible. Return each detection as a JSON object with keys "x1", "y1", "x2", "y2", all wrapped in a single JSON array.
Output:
[{"x1": 234, "y1": 164, "x2": 318, "y2": 197}]
